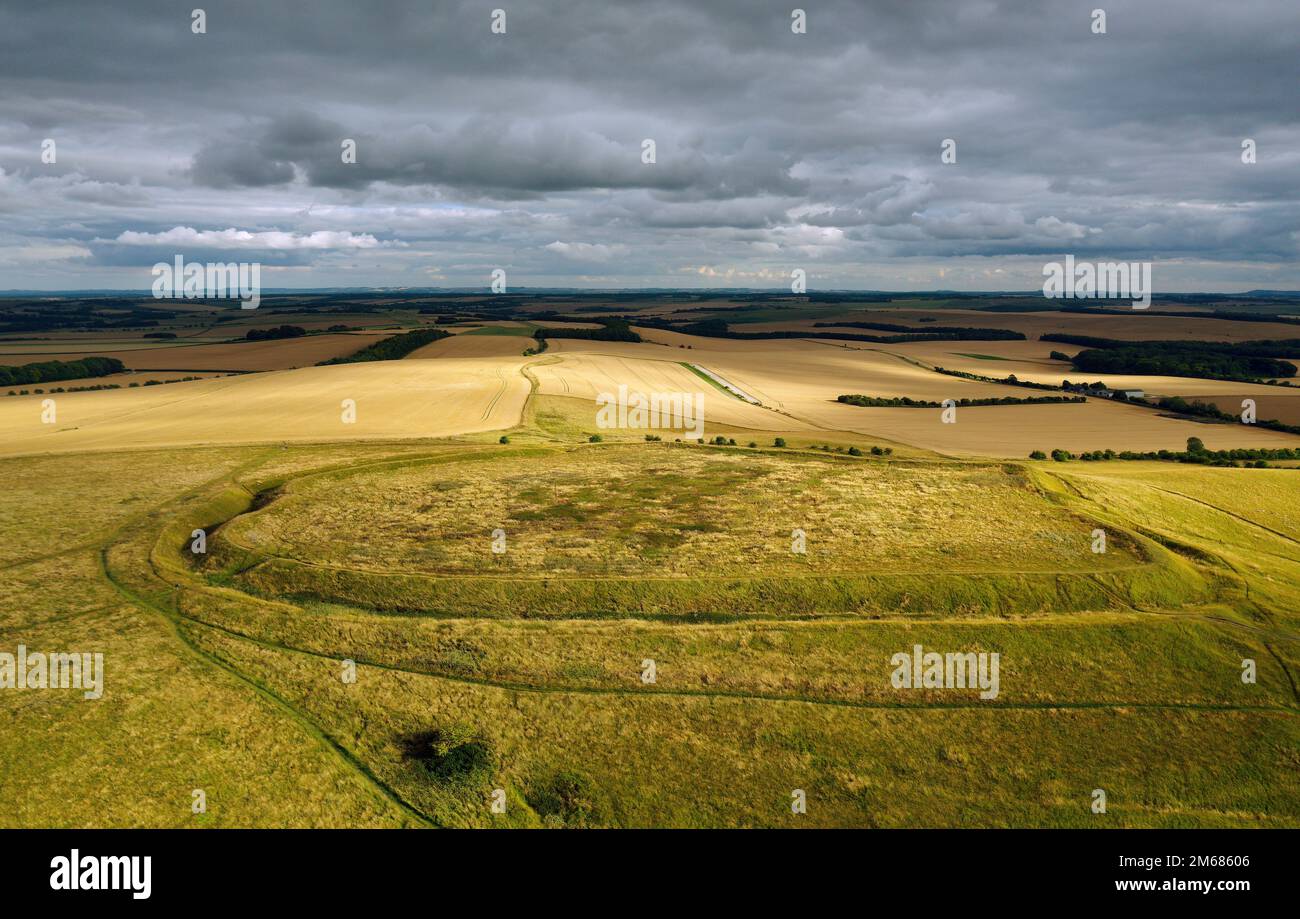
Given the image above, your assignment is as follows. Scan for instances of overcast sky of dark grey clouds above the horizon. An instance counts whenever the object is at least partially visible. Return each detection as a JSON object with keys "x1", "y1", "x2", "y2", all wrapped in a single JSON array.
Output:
[{"x1": 0, "y1": 0, "x2": 1300, "y2": 292}]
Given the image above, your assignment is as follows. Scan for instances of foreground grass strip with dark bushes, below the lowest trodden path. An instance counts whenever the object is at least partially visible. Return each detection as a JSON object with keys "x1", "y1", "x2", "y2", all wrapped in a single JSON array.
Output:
[{"x1": 195, "y1": 627, "x2": 1300, "y2": 827}]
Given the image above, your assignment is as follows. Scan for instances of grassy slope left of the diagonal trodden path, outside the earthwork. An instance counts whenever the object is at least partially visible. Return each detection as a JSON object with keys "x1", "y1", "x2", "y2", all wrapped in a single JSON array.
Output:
[{"x1": 0, "y1": 450, "x2": 412, "y2": 827}]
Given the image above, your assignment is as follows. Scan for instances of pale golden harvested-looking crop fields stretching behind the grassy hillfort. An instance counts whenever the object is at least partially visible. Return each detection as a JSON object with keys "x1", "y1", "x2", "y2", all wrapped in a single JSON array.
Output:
[{"x1": 0, "y1": 330, "x2": 1300, "y2": 458}]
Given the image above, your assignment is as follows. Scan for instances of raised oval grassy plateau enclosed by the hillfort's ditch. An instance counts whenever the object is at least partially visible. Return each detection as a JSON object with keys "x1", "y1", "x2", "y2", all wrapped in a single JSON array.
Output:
[{"x1": 202, "y1": 443, "x2": 1190, "y2": 620}]
